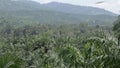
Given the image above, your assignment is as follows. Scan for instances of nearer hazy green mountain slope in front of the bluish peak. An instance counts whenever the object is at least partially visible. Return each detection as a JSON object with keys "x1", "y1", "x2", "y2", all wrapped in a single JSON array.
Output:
[{"x1": 0, "y1": 0, "x2": 117, "y2": 25}]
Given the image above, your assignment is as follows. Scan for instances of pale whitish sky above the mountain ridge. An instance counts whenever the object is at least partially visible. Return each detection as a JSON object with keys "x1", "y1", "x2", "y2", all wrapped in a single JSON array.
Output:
[{"x1": 33, "y1": 0, "x2": 120, "y2": 14}]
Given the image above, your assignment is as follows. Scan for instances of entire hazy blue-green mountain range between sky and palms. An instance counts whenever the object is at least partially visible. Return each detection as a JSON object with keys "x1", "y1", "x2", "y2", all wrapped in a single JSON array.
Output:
[{"x1": 0, "y1": 0, "x2": 117, "y2": 25}]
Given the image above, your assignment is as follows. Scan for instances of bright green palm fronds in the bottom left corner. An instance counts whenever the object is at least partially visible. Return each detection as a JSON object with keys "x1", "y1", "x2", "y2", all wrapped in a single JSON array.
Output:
[{"x1": 0, "y1": 53, "x2": 23, "y2": 68}]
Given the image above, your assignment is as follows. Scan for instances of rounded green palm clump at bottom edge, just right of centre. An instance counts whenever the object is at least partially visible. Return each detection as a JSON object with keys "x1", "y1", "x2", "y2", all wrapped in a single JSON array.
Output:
[{"x1": 58, "y1": 44, "x2": 83, "y2": 68}]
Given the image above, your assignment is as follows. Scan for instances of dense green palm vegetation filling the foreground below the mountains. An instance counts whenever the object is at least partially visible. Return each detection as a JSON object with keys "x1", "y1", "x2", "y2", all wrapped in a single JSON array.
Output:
[{"x1": 0, "y1": 15, "x2": 120, "y2": 68}]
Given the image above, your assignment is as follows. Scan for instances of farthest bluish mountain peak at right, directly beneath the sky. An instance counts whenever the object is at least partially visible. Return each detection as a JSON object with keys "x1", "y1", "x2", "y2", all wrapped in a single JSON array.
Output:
[{"x1": 44, "y1": 2, "x2": 116, "y2": 15}]
